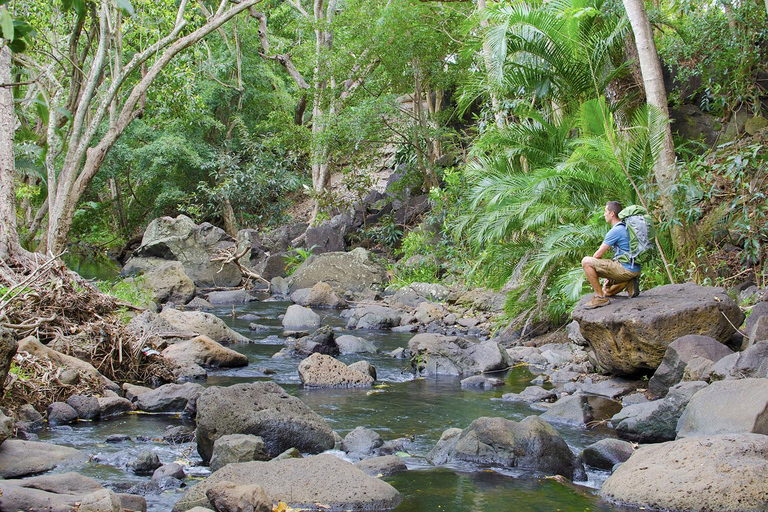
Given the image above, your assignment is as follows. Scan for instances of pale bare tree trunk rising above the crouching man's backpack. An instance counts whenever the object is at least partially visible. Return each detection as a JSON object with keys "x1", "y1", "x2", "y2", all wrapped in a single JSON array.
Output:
[{"x1": 624, "y1": 0, "x2": 677, "y2": 215}]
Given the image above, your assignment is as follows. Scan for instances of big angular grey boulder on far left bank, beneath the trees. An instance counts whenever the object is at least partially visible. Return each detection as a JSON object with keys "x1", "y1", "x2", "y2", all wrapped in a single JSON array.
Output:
[{"x1": 123, "y1": 215, "x2": 243, "y2": 288}]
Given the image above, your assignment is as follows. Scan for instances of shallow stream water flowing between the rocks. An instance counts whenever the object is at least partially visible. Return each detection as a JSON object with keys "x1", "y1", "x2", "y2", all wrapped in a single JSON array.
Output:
[{"x1": 39, "y1": 302, "x2": 628, "y2": 512}]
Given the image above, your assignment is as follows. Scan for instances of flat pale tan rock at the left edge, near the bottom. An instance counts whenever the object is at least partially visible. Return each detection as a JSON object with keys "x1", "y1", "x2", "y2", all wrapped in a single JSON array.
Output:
[{"x1": 0, "y1": 439, "x2": 88, "y2": 478}]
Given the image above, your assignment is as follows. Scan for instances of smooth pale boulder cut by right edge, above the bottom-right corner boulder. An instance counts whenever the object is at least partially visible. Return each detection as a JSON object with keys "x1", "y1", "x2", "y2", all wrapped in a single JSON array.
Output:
[{"x1": 677, "y1": 379, "x2": 768, "y2": 437}]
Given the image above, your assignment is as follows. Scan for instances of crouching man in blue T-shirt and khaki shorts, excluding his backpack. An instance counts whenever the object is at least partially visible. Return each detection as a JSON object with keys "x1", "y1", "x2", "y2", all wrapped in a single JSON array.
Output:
[{"x1": 581, "y1": 201, "x2": 640, "y2": 308}]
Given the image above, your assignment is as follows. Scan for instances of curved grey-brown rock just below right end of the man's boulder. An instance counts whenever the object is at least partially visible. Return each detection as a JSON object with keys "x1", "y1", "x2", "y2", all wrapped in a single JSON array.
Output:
[{"x1": 648, "y1": 334, "x2": 733, "y2": 397}]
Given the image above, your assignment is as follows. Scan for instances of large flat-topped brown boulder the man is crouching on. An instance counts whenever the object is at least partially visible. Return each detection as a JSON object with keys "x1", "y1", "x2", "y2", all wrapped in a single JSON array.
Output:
[{"x1": 572, "y1": 283, "x2": 744, "y2": 375}]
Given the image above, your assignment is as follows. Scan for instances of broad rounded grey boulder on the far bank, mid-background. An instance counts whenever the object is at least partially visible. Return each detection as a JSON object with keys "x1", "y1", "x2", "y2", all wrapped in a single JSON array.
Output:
[{"x1": 288, "y1": 247, "x2": 386, "y2": 293}]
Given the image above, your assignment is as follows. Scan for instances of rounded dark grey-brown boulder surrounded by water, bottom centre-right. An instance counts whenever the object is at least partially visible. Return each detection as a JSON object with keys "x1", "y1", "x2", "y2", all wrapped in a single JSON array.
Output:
[{"x1": 427, "y1": 416, "x2": 577, "y2": 479}]
